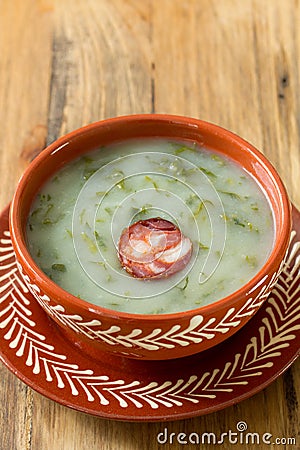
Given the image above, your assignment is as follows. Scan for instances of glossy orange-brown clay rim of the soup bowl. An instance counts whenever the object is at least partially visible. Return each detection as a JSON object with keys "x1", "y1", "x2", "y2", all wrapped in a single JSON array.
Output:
[{"x1": 9, "y1": 114, "x2": 291, "y2": 322}]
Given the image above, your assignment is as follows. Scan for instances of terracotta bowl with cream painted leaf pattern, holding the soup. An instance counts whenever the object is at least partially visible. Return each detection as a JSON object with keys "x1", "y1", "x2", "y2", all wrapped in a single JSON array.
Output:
[{"x1": 10, "y1": 115, "x2": 291, "y2": 360}]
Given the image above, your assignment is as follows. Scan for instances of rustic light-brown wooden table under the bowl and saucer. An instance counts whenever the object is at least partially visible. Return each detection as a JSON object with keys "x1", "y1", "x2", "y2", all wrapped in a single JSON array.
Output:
[{"x1": 0, "y1": 0, "x2": 300, "y2": 450}]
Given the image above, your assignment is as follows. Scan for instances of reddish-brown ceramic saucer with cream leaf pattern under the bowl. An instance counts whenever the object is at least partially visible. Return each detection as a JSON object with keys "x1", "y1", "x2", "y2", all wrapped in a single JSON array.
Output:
[{"x1": 0, "y1": 204, "x2": 300, "y2": 421}]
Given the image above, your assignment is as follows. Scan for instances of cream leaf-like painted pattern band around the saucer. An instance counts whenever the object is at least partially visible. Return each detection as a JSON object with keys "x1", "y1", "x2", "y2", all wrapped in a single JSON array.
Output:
[{"x1": 0, "y1": 232, "x2": 300, "y2": 409}]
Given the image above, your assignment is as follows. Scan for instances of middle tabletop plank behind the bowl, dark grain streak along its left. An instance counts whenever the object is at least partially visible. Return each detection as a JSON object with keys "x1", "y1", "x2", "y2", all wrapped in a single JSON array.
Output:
[{"x1": 48, "y1": 0, "x2": 151, "y2": 142}]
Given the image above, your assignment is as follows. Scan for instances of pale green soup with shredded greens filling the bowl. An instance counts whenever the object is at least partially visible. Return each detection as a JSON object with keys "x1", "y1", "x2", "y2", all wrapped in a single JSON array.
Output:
[{"x1": 27, "y1": 139, "x2": 274, "y2": 314}]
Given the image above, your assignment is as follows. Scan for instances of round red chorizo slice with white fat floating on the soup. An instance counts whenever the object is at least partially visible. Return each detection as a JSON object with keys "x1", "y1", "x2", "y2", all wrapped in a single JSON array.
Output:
[{"x1": 118, "y1": 217, "x2": 192, "y2": 278}]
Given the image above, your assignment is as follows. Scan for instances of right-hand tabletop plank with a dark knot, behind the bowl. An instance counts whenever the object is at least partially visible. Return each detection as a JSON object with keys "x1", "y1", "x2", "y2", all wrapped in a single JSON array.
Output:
[{"x1": 153, "y1": 0, "x2": 300, "y2": 207}]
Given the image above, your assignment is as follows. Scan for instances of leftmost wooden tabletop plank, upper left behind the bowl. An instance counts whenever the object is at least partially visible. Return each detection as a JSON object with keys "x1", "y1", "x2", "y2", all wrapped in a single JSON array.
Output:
[{"x1": 0, "y1": 0, "x2": 52, "y2": 208}]
